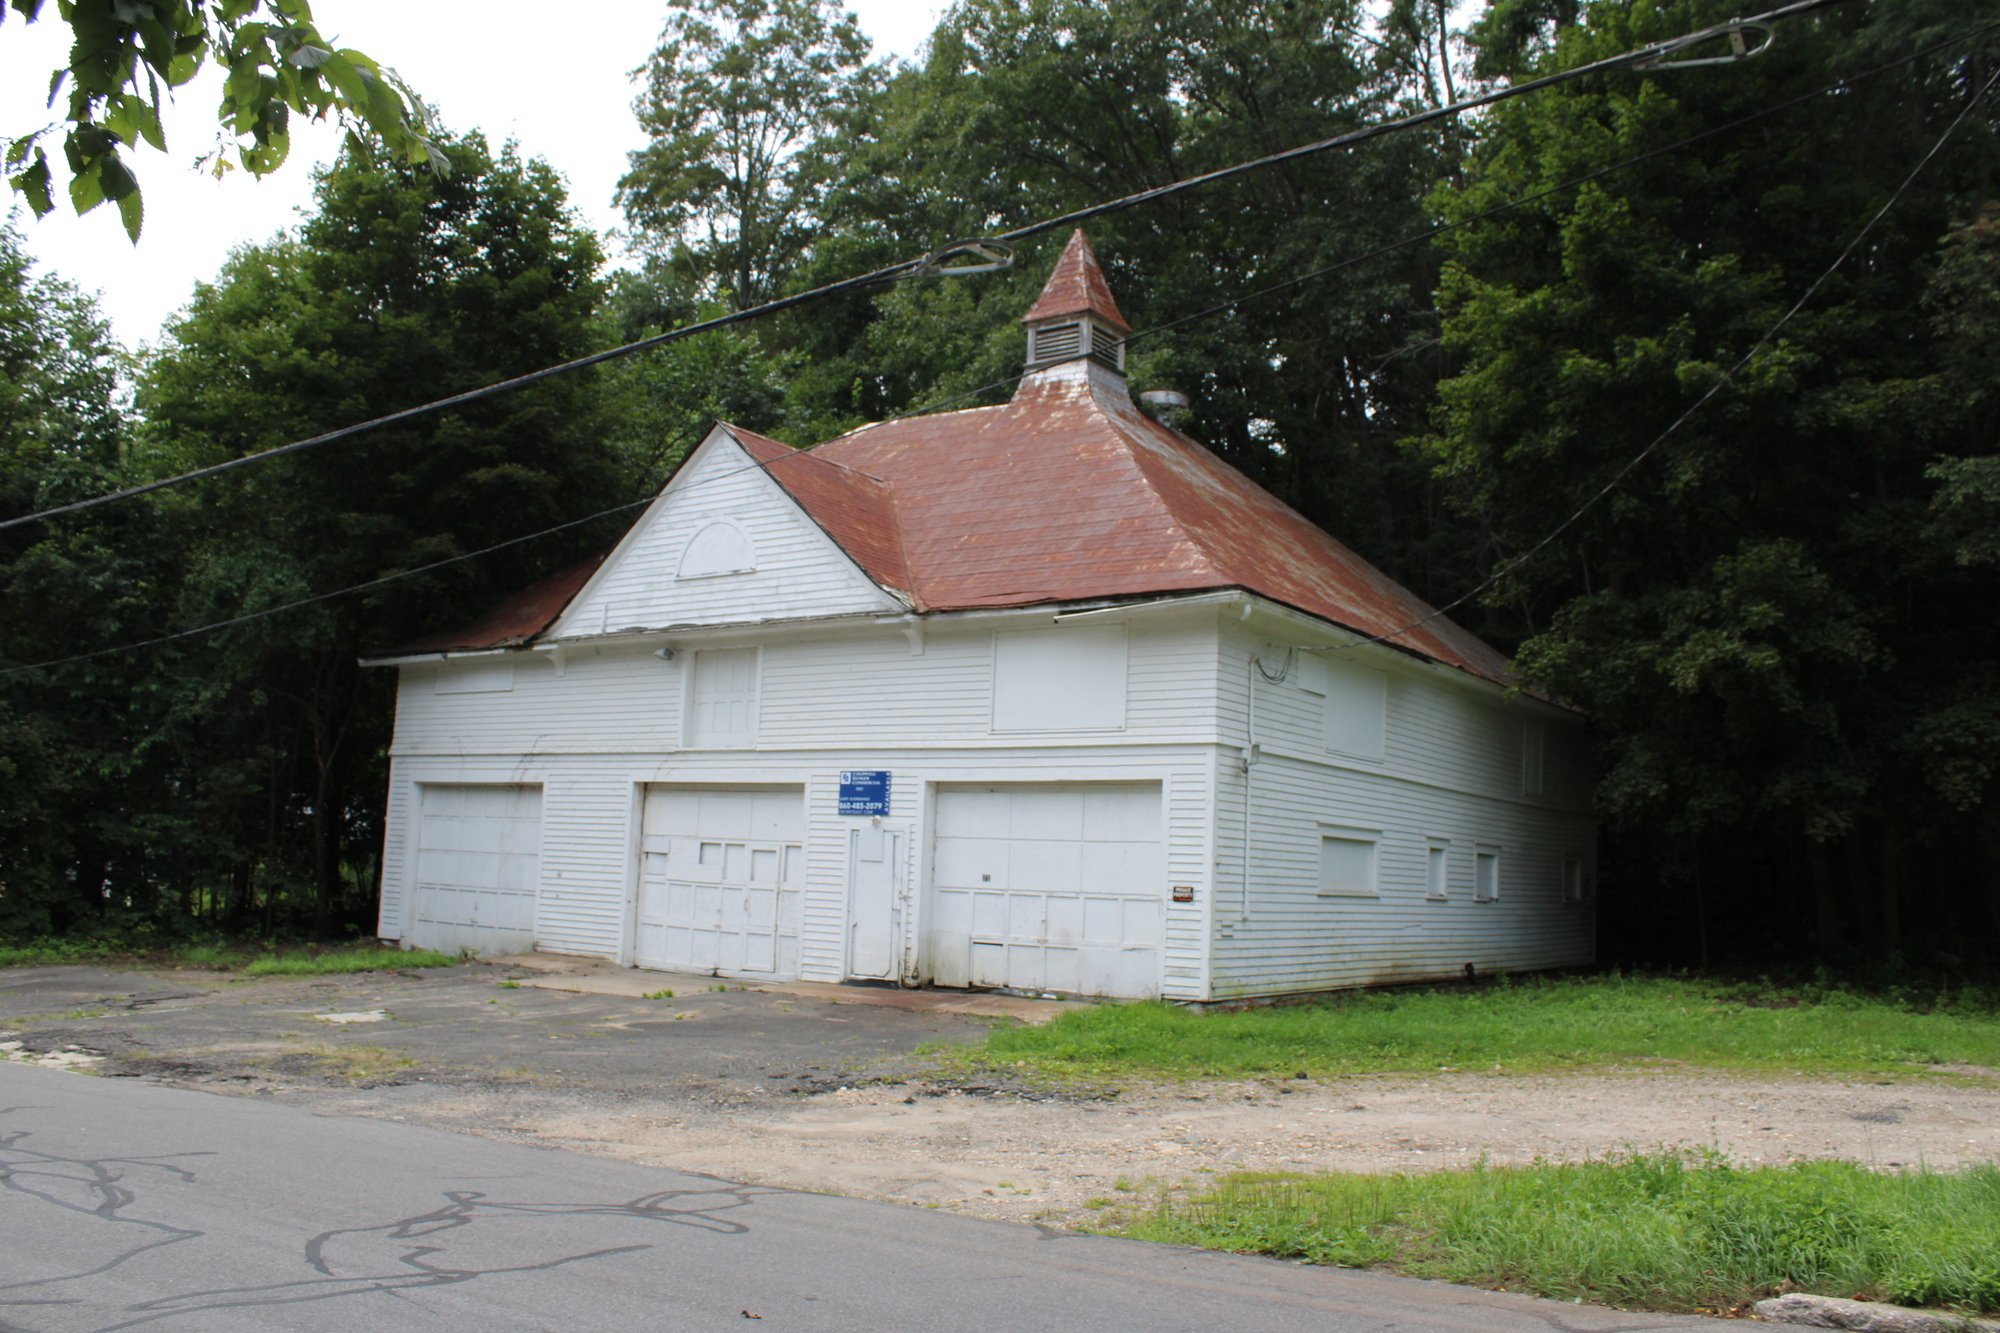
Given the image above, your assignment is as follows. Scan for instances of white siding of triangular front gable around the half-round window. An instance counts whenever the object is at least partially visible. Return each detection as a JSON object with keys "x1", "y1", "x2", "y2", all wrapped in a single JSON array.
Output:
[{"x1": 550, "y1": 428, "x2": 902, "y2": 638}]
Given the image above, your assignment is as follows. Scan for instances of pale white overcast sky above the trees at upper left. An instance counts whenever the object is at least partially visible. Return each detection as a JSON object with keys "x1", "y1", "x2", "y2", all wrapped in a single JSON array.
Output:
[{"x1": 0, "y1": 0, "x2": 942, "y2": 346}]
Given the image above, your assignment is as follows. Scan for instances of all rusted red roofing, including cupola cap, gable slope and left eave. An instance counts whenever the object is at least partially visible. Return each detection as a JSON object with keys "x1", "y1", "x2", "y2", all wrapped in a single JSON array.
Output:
[{"x1": 386, "y1": 232, "x2": 1512, "y2": 685}]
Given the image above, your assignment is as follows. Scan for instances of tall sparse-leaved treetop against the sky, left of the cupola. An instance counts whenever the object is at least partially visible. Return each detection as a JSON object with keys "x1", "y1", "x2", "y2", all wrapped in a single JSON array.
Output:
[{"x1": 618, "y1": 0, "x2": 882, "y2": 310}]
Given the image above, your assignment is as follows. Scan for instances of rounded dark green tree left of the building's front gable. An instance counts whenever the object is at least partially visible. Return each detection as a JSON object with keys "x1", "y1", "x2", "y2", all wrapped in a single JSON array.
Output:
[{"x1": 138, "y1": 134, "x2": 624, "y2": 929}]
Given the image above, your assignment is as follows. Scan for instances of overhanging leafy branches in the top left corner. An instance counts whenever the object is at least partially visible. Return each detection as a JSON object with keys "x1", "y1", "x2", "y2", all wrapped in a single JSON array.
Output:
[{"x1": 0, "y1": 0, "x2": 448, "y2": 240}]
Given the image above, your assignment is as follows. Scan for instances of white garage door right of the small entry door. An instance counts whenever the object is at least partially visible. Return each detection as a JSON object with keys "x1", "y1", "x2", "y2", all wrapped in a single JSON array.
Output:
[{"x1": 928, "y1": 783, "x2": 1164, "y2": 999}]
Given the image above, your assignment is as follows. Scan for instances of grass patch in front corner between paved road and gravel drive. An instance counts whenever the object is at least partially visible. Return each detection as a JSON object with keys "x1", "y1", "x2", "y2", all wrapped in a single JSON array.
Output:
[{"x1": 1124, "y1": 1151, "x2": 2000, "y2": 1313}]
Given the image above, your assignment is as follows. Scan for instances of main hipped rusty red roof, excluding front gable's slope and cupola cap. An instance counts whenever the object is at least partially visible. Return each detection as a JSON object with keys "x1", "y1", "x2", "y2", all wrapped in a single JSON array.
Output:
[{"x1": 804, "y1": 360, "x2": 1510, "y2": 683}]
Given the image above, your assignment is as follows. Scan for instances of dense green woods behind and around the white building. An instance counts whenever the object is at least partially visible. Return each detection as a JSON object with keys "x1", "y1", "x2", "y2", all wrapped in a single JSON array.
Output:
[{"x1": 0, "y1": 0, "x2": 2000, "y2": 965}]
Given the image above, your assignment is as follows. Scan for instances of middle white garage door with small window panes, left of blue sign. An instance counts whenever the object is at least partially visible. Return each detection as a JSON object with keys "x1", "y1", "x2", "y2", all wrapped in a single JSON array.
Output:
[{"x1": 636, "y1": 787, "x2": 806, "y2": 977}]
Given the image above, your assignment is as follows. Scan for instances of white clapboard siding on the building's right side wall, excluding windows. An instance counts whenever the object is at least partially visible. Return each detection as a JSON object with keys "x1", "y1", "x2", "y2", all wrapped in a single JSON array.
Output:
[{"x1": 1210, "y1": 626, "x2": 1596, "y2": 999}]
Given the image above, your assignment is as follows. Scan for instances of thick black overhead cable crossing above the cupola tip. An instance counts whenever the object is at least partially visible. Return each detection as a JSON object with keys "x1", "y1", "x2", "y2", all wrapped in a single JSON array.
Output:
[{"x1": 0, "y1": 0, "x2": 1848, "y2": 530}]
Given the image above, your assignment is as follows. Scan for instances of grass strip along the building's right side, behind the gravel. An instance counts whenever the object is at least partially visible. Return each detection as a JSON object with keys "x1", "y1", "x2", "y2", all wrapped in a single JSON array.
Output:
[{"x1": 964, "y1": 975, "x2": 2000, "y2": 1077}]
